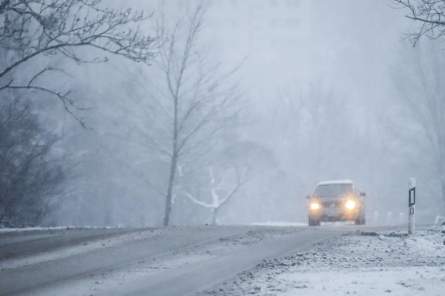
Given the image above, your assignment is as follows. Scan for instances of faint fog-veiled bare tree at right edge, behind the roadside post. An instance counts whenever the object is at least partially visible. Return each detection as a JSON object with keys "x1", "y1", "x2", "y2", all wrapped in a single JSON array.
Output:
[{"x1": 394, "y1": 43, "x2": 445, "y2": 213}]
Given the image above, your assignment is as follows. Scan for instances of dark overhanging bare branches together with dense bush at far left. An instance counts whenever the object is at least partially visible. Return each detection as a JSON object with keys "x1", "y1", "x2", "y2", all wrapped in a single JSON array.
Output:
[{"x1": 0, "y1": 0, "x2": 158, "y2": 226}]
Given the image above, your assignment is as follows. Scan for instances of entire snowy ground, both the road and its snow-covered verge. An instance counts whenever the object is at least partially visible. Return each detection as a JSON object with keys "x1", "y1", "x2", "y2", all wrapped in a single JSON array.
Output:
[{"x1": 0, "y1": 222, "x2": 445, "y2": 296}]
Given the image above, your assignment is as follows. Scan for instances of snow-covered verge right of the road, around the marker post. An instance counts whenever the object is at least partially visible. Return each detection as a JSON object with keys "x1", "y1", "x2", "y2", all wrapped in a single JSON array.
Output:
[{"x1": 203, "y1": 226, "x2": 445, "y2": 296}]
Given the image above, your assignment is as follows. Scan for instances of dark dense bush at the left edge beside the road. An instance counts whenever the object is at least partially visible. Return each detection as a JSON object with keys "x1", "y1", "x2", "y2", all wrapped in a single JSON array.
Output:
[{"x1": 0, "y1": 95, "x2": 64, "y2": 227}]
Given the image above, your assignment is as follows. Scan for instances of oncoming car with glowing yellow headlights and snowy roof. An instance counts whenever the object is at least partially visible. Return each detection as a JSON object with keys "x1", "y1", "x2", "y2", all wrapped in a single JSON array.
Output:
[{"x1": 307, "y1": 180, "x2": 366, "y2": 226}]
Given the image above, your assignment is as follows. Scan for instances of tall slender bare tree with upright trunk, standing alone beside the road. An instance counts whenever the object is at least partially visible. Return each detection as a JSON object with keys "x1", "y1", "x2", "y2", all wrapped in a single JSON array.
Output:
[{"x1": 125, "y1": 0, "x2": 241, "y2": 226}]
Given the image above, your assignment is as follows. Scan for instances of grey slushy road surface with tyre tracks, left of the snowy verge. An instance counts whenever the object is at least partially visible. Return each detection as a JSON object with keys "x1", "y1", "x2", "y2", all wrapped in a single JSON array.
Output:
[{"x1": 0, "y1": 225, "x2": 396, "y2": 296}]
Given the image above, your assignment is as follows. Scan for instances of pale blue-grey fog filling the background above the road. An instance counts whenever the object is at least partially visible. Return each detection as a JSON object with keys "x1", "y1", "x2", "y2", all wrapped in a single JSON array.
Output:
[{"x1": 0, "y1": 0, "x2": 445, "y2": 227}]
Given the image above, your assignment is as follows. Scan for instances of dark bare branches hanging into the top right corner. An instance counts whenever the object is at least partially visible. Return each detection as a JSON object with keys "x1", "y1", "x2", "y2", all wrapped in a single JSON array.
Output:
[{"x1": 392, "y1": 0, "x2": 445, "y2": 46}]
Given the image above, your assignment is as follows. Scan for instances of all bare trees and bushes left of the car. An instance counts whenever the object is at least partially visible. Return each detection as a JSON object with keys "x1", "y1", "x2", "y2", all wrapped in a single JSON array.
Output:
[{"x1": 0, "y1": 0, "x2": 273, "y2": 226}]
